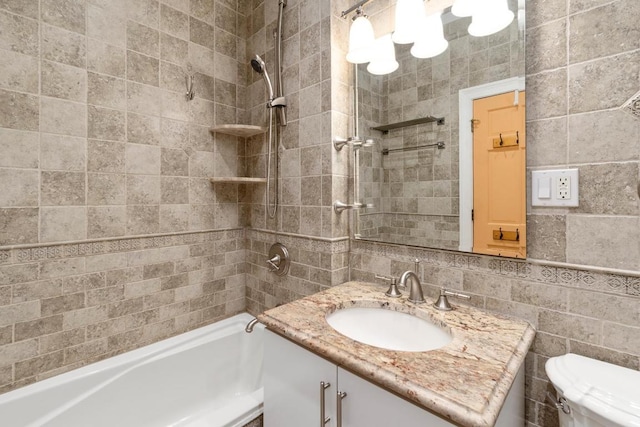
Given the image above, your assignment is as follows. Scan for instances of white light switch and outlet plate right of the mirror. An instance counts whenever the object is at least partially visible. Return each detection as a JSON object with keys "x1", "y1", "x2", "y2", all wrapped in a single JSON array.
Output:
[{"x1": 531, "y1": 169, "x2": 579, "y2": 207}]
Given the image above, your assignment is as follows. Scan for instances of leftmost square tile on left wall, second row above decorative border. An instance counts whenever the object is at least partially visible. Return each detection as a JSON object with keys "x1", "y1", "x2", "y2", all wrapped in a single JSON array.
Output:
[{"x1": 0, "y1": 168, "x2": 39, "y2": 208}]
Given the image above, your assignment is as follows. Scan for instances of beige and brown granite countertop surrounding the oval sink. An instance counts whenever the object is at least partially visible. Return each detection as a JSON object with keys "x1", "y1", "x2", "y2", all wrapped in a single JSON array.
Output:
[{"x1": 258, "y1": 282, "x2": 535, "y2": 427}]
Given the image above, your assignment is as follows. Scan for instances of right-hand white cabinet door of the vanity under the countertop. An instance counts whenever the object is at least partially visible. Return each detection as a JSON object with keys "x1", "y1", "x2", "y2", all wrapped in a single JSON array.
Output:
[{"x1": 338, "y1": 368, "x2": 454, "y2": 427}]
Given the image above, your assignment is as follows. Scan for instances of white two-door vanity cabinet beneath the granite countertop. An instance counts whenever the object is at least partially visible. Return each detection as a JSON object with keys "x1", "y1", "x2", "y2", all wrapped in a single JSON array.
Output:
[{"x1": 264, "y1": 330, "x2": 453, "y2": 427}]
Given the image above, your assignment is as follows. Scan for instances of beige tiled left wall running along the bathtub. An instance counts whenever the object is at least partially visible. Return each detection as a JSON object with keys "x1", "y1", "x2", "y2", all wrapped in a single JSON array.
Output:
[{"x1": 0, "y1": 0, "x2": 250, "y2": 391}]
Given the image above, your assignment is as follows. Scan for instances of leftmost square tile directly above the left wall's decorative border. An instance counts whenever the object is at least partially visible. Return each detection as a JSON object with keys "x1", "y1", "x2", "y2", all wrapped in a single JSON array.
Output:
[{"x1": 0, "y1": 208, "x2": 39, "y2": 245}]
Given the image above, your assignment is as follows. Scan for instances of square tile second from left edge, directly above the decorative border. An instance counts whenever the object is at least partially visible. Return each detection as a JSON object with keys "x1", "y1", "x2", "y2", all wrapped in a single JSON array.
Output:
[{"x1": 40, "y1": 206, "x2": 87, "y2": 242}]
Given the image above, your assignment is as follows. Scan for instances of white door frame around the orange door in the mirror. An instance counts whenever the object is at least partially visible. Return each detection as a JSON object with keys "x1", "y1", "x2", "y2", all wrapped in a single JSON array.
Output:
[{"x1": 458, "y1": 77, "x2": 525, "y2": 252}]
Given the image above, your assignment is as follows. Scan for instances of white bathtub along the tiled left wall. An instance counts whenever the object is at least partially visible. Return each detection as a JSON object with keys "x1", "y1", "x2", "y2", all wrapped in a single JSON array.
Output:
[{"x1": 0, "y1": 314, "x2": 264, "y2": 427}]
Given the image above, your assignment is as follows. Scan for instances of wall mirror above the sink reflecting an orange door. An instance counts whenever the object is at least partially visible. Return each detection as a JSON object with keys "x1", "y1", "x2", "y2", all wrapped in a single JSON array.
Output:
[{"x1": 354, "y1": 0, "x2": 526, "y2": 258}]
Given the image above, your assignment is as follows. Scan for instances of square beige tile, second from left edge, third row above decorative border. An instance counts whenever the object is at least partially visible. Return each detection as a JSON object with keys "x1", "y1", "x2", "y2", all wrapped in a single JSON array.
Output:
[{"x1": 40, "y1": 134, "x2": 87, "y2": 171}]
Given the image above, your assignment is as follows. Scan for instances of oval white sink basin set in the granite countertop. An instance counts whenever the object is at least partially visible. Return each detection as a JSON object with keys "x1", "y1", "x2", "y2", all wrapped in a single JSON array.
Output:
[{"x1": 327, "y1": 307, "x2": 453, "y2": 351}]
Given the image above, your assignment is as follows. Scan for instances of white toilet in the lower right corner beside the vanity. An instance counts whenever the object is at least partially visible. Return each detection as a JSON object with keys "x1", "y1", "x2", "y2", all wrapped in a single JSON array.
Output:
[{"x1": 545, "y1": 353, "x2": 640, "y2": 427}]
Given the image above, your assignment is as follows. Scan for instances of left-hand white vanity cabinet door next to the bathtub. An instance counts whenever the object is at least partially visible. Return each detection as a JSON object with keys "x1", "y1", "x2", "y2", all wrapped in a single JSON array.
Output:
[{"x1": 264, "y1": 330, "x2": 337, "y2": 427}]
